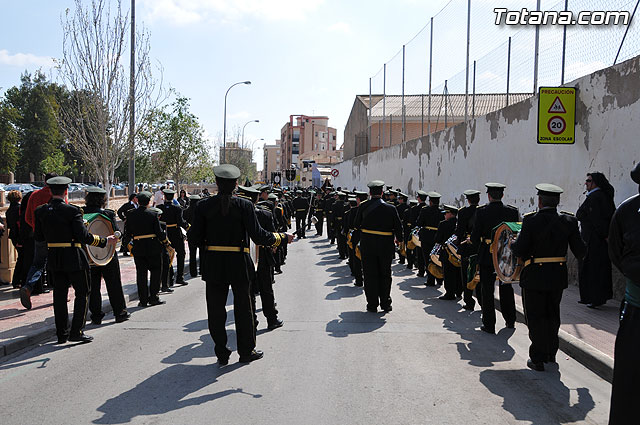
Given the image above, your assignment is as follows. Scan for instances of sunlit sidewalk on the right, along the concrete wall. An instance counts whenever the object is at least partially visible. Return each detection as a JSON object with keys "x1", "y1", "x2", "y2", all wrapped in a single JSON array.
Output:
[{"x1": 496, "y1": 285, "x2": 620, "y2": 382}]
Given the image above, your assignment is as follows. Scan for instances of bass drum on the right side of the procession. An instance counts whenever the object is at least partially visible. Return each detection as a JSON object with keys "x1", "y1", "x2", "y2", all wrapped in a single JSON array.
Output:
[{"x1": 491, "y1": 222, "x2": 523, "y2": 283}]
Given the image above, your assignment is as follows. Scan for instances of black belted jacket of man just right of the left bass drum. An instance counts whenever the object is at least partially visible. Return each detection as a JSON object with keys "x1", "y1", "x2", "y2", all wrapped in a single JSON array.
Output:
[{"x1": 124, "y1": 206, "x2": 169, "y2": 261}]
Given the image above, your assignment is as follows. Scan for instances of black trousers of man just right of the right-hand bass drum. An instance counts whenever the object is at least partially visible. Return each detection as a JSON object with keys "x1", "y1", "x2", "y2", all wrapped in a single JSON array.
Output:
[{"x1": 522, "y1": 288, "x2": 562, "y2": 363}]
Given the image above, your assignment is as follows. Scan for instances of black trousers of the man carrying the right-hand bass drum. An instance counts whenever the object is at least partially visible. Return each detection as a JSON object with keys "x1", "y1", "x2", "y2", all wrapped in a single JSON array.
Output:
[{"x1": 480, "y1": 264, "x2": 516, "y2": 329}]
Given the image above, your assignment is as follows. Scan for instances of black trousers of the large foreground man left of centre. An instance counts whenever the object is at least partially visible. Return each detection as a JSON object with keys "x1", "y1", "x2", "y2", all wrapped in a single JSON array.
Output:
[{"x1": 206, "y1": 279, "x2": 256, "y2": 357}]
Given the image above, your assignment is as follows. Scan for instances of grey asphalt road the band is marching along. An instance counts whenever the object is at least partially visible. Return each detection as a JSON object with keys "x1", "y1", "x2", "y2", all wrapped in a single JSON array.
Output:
[{"x1": 0, "y1": 232, "x2": 611, "y2": 425}]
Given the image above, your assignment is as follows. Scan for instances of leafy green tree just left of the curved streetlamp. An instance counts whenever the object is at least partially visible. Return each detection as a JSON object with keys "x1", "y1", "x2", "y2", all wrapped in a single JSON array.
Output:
[{"x1": 141, "y1": 97, "x2": 206, "y2": 189}]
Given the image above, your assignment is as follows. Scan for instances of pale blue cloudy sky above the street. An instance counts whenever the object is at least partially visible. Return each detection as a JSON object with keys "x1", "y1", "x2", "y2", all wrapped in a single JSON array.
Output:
[{"x1": 0, "y1": 0, "x2": 632, "y2": 168}]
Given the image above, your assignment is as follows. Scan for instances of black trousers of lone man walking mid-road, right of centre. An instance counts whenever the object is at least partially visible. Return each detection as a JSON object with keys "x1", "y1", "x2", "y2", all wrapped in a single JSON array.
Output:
[{"x1": 360, "y1": 246, "x2": 393, "y2": 309}]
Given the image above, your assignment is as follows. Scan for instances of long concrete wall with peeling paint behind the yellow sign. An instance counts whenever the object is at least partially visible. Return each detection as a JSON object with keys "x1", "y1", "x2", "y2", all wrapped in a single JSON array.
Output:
[{"x1": 334, "y1": 53, "x2": 640, "y2": 298}]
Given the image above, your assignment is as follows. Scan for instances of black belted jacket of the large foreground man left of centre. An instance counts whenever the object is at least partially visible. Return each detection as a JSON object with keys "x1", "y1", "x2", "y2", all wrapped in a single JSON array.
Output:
[{"x1": 188, "y1": 195, "x2": 287, "y2": 283}]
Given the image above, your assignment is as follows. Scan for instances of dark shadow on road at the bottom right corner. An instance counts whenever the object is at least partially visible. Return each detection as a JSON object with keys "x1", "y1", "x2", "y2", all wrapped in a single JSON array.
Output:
[{"x1": 480, "y1": 365, "x2": 595, "y2": 425}]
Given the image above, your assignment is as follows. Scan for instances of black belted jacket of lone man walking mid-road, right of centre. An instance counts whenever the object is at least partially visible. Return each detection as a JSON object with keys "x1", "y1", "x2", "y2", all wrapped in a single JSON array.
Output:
[{"x1": 351, "y1": 198, "x2": 404, "y2": 255}]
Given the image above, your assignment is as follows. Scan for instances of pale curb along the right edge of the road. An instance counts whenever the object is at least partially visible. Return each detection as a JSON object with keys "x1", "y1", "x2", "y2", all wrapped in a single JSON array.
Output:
[{"x1": 494, "y1": 298, "x2": 613, "y2": 383}]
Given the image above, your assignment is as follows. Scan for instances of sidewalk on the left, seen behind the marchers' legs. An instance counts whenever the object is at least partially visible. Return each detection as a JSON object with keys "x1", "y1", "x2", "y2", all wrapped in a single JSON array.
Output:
[{"x1": 0, "y1": 253, "x2": 138, "y2": 358}]
